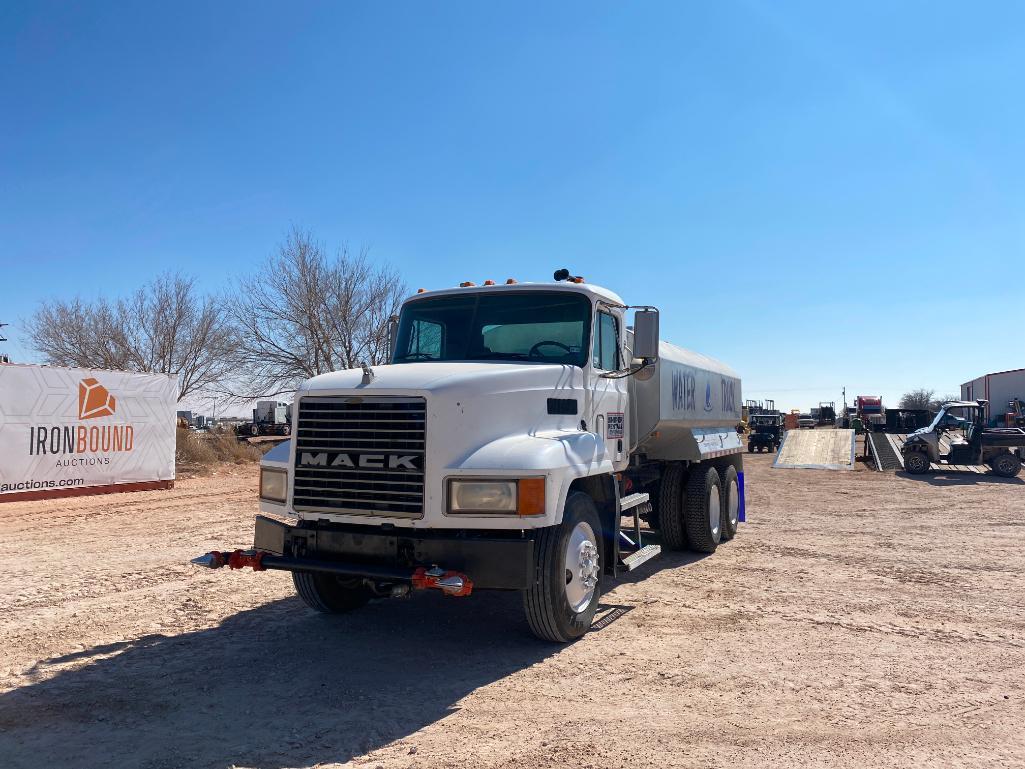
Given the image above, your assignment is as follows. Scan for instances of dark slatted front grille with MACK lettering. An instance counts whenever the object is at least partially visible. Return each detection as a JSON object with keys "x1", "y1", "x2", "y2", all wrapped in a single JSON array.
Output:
[{"x1": 292, "y1": 396, "x2": 426, "y2": 518}]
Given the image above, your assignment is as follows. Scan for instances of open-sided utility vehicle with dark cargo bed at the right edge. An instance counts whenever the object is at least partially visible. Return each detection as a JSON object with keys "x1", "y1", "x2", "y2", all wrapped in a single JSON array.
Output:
[{"x1": 901, "y1": 400, "x2": 1025, "y2": 478}]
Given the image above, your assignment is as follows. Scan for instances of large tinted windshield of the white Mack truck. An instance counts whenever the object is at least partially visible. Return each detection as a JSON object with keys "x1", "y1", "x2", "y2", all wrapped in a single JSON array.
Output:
[{"x1": 393, "y1": 291, "x2": 590, "y2": 367}]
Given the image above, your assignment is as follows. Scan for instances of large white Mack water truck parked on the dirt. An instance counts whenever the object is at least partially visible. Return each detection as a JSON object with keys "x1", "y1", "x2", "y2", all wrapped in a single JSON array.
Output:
[{"x1": 193, "y1": 270, "x2": 744, "y2": 642}]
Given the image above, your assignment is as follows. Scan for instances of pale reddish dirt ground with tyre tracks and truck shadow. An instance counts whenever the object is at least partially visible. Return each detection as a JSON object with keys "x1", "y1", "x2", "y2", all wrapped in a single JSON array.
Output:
[{"x1": 0, "y1": 454, "x2": 1025, "y2": 769}]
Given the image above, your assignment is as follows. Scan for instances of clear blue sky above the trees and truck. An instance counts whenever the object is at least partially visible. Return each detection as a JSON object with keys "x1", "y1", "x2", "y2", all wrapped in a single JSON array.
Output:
[{"x1": 0, "y1": 2, "x2": 1025, "y2": 416}]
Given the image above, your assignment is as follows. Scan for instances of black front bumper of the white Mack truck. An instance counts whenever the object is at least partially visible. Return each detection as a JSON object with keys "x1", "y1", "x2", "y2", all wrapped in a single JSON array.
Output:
[{"x1": 253, "y1": 516, "x2": 535, "y2": 590}]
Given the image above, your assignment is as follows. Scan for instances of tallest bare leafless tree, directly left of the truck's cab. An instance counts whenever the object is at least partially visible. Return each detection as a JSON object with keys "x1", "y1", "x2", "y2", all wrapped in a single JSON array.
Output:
[{"x1": 228, "y1": 230, "x2": 406, "y2": 398}]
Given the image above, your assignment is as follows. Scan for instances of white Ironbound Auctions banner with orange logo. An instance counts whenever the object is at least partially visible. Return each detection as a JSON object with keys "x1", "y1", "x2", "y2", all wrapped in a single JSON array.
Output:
[{"x1": 0, "y1": 365, "x2": 178, "y2": 498}]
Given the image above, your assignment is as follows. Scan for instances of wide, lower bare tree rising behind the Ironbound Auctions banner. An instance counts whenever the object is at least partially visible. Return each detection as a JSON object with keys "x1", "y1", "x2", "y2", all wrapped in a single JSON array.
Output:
[{"x1": 26, "y1": 275, "x2": 231, "y2": 401}]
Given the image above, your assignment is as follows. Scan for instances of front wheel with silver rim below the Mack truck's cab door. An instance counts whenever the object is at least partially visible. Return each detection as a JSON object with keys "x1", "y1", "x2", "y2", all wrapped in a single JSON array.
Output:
[{"x1": 523, "y1": 491, "x2": 603, "y2": 644}]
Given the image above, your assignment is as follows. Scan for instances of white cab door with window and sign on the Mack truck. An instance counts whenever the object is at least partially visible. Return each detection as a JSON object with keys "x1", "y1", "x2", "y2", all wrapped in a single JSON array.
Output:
[{"x1": 589, "y1": 306, "x2": 629, "y2": 471}]
